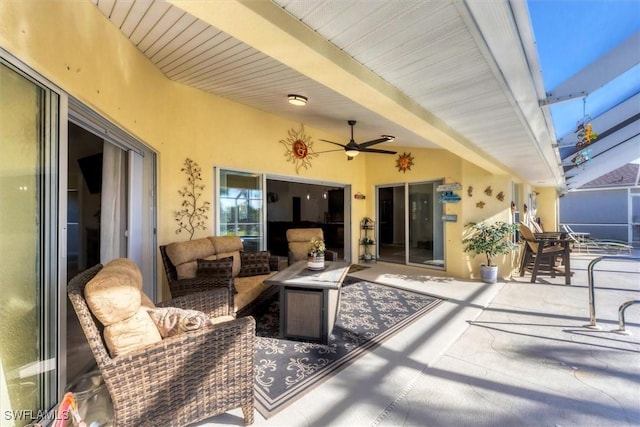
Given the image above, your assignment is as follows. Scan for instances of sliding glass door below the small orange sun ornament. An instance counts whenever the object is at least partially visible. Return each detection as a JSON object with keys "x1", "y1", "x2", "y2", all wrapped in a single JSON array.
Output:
[{"x1": 377, "y1": 182, "x2": 444, "y2": 268}]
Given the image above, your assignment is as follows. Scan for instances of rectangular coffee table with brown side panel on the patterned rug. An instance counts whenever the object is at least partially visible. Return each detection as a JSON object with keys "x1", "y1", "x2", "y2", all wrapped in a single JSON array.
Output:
[{"x1": 265, "y1": 260, "x2": 351, "y2": 344}]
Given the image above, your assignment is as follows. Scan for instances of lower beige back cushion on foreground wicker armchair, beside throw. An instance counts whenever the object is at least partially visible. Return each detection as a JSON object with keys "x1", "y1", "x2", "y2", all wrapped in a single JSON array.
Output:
[{"x1": 104, "y1": 308, "x2": 162, "y2": 357}]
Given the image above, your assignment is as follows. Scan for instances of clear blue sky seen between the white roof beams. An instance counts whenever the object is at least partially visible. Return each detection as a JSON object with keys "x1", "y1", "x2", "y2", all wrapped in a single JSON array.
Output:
[{"x1": 527, "y1": 0, "x2": 640, "y2": 139}]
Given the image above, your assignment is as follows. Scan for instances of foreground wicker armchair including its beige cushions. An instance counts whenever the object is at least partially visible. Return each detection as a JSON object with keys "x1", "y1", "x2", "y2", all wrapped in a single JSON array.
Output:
[{"x1": 68, "y1": 259, "x2": 255, "y2": 427}]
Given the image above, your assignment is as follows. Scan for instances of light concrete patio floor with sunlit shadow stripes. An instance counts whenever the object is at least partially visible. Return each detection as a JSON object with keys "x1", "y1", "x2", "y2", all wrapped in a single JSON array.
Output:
[{"x1": 197, "y1": 250, "x2": 640, "y2": 427}]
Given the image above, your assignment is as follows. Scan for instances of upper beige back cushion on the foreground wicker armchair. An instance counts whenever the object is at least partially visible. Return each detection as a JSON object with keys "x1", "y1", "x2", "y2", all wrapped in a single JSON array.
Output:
[{"x1": 84, "y1": 260, "x2": 142, "y2": 326}]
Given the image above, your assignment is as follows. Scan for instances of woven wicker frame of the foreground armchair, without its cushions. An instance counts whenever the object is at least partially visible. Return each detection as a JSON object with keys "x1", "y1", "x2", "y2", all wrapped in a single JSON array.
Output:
[{"x1": 68, "y1": 265, "x2": 255, "y2": 427}]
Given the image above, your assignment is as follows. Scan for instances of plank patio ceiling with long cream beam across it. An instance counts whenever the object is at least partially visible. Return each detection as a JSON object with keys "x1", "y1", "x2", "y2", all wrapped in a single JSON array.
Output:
[{"x1": 90, "y1": 0, "x2": 565, "y2": 190}]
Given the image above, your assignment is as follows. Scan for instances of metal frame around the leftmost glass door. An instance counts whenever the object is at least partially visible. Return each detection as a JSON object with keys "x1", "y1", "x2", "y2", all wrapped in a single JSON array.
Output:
[{"x1": 0, "y1": 48, "x2": 67, "y2": 421}]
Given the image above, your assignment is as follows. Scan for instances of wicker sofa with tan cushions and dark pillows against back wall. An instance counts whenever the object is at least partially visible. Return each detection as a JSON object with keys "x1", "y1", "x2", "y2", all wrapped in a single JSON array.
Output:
[{"x1": 160, "y1": 236, "x2": 287, "y2": 316}]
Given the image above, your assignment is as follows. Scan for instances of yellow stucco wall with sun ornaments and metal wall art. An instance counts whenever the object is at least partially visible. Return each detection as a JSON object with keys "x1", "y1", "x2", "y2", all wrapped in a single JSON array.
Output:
[{"x1": 0, "y1": 0, "x2": 540, "y2": 292}]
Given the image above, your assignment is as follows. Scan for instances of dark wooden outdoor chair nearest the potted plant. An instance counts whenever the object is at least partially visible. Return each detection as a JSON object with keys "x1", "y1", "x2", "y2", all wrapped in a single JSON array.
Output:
[{"x1": 520, "y1": 223, "x2": 571, "y2": 285}]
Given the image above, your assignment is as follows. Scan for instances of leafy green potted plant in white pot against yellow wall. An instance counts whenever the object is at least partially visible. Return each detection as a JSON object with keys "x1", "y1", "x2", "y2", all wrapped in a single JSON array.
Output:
[{"x1": 462, "y1": 221, "x2": 518, "y2": 283}]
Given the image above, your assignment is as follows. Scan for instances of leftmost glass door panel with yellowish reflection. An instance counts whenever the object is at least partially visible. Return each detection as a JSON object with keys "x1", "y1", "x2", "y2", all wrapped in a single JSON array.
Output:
[{"x1": 0, "y1": 60, "x2": 58, "y2": 426}]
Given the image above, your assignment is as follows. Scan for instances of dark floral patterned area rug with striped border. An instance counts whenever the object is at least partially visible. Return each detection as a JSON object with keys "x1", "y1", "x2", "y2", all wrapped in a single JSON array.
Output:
[{"x1": 253, "y1": 277, "x2": 442, "y2": 418}]
